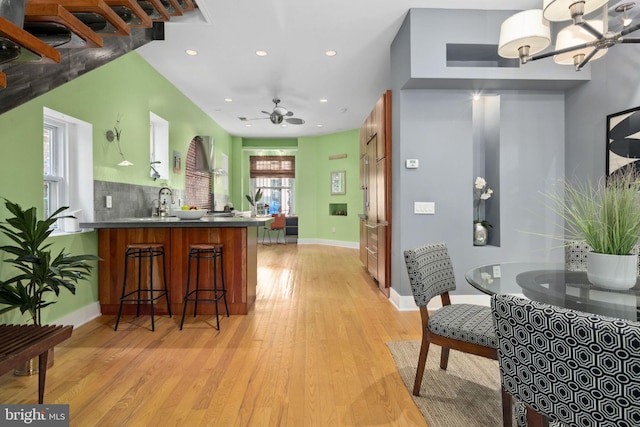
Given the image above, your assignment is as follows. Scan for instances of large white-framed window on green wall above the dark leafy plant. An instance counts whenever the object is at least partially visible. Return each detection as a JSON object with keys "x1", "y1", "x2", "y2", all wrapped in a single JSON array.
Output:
[{"x1": 42, "y1": 108, "x2": 94, "y2": 232}]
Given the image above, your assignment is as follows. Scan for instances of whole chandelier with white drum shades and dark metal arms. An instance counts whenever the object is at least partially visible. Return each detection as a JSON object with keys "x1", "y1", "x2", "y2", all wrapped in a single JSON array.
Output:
[{"x1": 498, "y1": 0, "x2": 640, "y2": 71}]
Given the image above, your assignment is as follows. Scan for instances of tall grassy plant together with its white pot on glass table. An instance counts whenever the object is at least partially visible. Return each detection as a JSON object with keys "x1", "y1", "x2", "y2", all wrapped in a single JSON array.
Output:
[{"x1": 547, "y1": 168, "x2": 640, "y2": 289}]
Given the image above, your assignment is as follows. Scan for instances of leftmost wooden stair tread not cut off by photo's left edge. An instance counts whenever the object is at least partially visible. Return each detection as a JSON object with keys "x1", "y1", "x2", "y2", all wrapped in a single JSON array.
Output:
[{"x1": 24, "y1": 1, "x2": 102, "y2": 48}]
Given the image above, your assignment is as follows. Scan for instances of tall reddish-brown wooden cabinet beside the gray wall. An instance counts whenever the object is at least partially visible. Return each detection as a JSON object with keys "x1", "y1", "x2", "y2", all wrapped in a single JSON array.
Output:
[{"x1": 360, "y1": 91, "x2": 391, "y2": 296}]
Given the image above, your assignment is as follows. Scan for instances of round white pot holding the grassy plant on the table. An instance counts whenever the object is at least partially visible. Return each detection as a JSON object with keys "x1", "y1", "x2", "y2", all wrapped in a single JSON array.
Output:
[{"x1": 587, "y1": 252, "x2": 638, "y2": 290}]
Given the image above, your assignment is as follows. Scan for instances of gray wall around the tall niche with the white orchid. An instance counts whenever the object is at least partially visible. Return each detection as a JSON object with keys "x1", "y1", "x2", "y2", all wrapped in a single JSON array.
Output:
[{"x1": 391, "y1": 10, "x2": 568, "y2": 296}]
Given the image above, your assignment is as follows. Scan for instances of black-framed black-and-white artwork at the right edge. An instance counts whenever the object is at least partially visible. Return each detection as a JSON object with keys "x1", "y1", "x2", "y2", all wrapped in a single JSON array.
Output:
[{"x1": 607, "y1": 107, "x2": 640, "y2": 176}]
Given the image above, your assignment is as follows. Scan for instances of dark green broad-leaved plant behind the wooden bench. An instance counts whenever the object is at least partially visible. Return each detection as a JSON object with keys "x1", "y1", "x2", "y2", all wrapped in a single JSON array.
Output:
[{"x1": 0, "y1": 199, "x2": 100, "y2": 325}]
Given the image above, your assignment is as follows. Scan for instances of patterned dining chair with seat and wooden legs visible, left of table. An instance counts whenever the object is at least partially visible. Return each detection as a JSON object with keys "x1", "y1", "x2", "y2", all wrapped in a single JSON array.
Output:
[{"x1": 404, "y1": 243, "x2": 498, "y2": 396}]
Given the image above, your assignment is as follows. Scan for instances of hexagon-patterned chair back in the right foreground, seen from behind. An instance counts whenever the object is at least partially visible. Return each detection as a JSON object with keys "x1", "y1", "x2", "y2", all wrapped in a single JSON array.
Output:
[{"x1": 491, "y1": 295, "x2": 640, "y2": 427}]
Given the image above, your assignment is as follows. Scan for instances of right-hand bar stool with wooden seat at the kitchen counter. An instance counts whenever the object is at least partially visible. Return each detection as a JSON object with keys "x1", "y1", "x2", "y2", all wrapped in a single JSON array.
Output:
[{"x1": 180, "y1": 243, "x2": 229, "y2": 330}]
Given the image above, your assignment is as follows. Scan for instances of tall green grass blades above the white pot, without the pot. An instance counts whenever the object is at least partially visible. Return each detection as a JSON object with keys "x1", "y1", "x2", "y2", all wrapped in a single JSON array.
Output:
[{"x1": 545, "y1": 168, "x2": 640, "y2": 255}]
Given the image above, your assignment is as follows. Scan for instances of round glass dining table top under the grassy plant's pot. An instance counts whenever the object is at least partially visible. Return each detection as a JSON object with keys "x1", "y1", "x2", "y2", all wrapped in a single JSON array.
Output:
[{"x1": 465, "y1": 262, "x2": 640, "y2": 321}]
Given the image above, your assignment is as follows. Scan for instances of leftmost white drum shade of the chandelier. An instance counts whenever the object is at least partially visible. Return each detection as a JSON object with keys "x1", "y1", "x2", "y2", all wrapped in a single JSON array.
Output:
[{"x1": 498, "y1": 9, "x2": 551, "y2": 58}]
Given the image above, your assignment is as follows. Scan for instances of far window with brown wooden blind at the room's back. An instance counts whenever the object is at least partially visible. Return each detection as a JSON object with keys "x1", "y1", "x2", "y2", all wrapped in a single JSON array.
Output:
[{"x1": 249, "y1": 156, "x2": 296, "y2": 214}]
